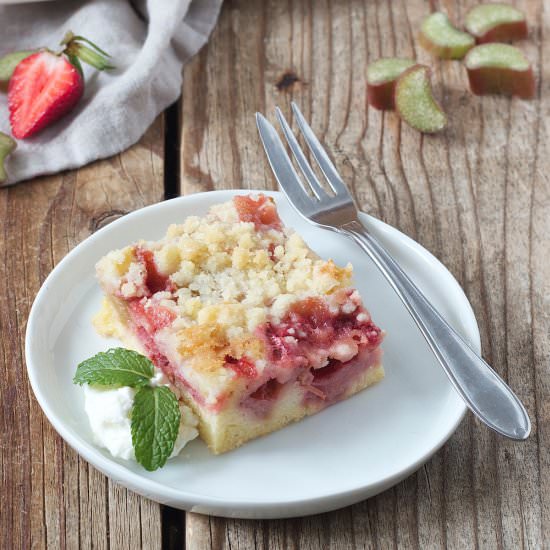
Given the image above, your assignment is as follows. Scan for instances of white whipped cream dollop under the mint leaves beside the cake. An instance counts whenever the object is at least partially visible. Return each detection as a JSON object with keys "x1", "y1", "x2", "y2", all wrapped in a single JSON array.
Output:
[{"x1": 84, "y1": 371, "x2": 199, "y2": 460}]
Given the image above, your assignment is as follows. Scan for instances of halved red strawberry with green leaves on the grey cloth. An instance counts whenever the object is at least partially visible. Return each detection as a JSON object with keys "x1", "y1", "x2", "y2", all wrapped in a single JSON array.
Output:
[{"x1": 8, "y1": 33, "x2": 113, "y2": 139}]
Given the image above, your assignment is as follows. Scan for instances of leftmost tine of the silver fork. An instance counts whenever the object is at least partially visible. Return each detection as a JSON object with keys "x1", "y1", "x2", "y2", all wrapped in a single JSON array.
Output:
[{"x1": 256, "y1": 113, "x2": 314, "y2": 217}]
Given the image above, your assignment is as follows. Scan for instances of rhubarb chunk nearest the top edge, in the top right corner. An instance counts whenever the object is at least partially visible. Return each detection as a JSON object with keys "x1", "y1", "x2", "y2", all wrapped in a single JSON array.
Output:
[{"x1": 465, "y1": 4, "x2": 527, "y2": 44}]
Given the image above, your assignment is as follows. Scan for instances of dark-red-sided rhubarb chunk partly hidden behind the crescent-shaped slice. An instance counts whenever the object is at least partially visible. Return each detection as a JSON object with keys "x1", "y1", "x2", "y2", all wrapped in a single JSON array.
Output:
[{"x1": 367, "y1": 57, "x2": 415, "y2": 110}]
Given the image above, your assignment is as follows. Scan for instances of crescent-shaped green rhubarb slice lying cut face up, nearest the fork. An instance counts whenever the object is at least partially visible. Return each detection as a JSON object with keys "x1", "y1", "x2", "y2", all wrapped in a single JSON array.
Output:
[{"x1": 395, "y1": 65, "x2": 447, "y2": 133}]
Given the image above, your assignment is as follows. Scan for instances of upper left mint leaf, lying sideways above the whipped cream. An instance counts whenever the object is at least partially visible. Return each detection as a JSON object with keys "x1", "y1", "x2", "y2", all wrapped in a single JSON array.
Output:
[{"x1": 73, "y1": 348, "x2": 154, "y2": 388}]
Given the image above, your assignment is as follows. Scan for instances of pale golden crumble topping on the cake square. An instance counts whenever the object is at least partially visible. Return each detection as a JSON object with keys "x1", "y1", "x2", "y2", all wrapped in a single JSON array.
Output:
[{"x1": 97, "y1": 196, "x2": 352, "y2": 338}]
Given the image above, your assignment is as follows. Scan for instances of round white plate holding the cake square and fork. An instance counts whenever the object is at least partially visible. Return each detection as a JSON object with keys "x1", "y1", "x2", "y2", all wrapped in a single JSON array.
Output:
[{"x1": 26, "y1": 191, "x2": 480, "y2": 518}]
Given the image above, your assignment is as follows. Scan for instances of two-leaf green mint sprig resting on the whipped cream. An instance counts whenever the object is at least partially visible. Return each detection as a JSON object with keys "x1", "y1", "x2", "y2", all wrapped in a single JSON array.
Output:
[{"x1": 73, "y1": 348, "x2": 181, "y2": 472}]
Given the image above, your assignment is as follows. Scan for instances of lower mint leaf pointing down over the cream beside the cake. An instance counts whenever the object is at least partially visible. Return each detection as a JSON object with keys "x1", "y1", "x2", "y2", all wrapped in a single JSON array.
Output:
[{"x1": 131, "y1": 386, "x2": 181, "y2": 472}]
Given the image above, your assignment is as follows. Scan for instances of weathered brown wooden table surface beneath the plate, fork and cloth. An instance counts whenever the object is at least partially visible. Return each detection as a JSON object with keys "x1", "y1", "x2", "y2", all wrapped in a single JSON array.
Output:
[{"x1": 0, "y1": 0, "x2": 550, "y2": 549}]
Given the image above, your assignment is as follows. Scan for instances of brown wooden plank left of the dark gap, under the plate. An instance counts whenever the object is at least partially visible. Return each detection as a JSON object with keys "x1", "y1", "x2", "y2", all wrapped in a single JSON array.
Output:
[{"x1": 0, "y1": 118, "x2": 164, "y2": 549}]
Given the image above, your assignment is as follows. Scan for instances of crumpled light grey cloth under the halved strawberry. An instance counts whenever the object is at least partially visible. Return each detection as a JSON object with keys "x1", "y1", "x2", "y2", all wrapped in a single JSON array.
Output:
[{"x1": 0, "y1": 0, "x2": 222, "y2": 185}]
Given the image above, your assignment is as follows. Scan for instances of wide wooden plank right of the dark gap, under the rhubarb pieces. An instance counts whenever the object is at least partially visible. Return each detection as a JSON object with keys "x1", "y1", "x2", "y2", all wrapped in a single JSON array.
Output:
[{"x1": 181, "y1": 0, "x2": 550, "y2": 549}]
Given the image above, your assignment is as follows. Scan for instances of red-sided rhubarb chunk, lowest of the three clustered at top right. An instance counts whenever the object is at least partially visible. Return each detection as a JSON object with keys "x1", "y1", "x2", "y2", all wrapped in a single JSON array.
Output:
[{"x1": 465, "y1": 44, "x2": 535, "y2": 99}]
